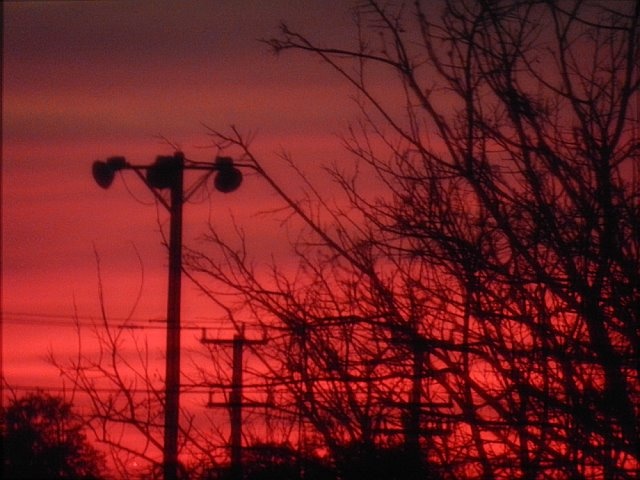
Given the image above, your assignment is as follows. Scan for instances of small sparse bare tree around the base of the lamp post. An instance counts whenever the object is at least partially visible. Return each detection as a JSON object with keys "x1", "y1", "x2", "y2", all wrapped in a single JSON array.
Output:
[{"x1": 50, "y1": 253, "x2": 225, "y2": 478}]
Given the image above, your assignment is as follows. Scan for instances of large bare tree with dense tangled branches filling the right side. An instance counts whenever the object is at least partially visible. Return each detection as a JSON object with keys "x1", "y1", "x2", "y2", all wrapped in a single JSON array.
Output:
[{"x1": 189, "y1": 0, "x2": 640, "y2": 478}]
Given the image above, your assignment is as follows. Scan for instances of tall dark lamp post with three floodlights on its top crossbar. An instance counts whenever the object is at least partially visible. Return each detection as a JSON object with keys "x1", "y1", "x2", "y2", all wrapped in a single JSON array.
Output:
[{"x1": 92, "y1": 152, "x2": 242, "y2": 480}]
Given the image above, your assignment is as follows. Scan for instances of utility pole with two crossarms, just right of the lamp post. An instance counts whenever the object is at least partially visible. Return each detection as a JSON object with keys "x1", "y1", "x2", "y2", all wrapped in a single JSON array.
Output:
[{"x1": 200, "y1": 325, "x2": 266, "y2": 480}]
